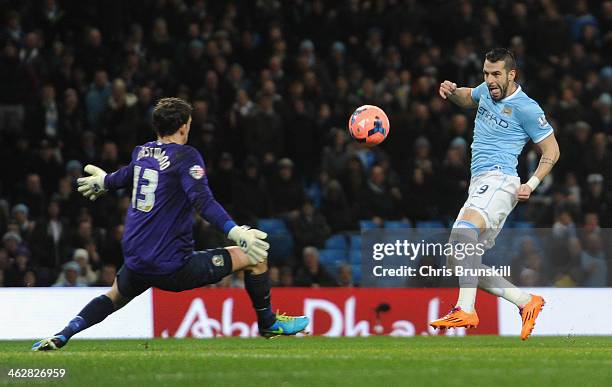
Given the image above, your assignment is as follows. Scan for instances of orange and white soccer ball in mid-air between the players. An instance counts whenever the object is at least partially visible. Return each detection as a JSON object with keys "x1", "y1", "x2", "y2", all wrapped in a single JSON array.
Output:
[{"x1": 349, "y1": 105, "x2": 390, "y2": 146}]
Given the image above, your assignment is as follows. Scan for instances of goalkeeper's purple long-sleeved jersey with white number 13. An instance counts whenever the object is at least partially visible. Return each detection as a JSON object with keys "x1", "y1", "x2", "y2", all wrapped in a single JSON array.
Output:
[{"x1": 104, "y1": 141, "x2": 235, "y2": 275}]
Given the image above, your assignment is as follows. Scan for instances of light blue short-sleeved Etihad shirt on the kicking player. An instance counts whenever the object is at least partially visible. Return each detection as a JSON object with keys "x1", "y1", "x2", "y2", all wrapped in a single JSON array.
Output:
[{"x1": 471, "y1": 82, "x2": 553, "y2": 176}]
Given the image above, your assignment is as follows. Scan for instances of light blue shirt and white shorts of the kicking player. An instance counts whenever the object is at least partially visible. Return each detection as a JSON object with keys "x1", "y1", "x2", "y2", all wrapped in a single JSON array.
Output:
[{"x1": 458, "y1": 82, "x2": 553, "y2": 248}]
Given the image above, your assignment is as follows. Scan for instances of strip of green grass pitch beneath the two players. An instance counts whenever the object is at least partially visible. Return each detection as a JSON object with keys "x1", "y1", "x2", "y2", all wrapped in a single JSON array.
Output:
[{"x1": 0, "y1": 336, "x2": 612, "y2": 387}]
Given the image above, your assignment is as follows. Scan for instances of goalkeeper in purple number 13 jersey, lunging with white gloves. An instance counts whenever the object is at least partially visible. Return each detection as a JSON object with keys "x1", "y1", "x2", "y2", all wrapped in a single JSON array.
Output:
[{"x1": 32, "y1": 98, "x2": 309, "y2": 351}]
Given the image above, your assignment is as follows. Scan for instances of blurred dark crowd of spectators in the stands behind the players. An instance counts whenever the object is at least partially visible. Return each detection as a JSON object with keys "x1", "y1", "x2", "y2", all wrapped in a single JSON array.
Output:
[{"x1": 0, "y1": 0, "x2": 612, "y2": 286}]
